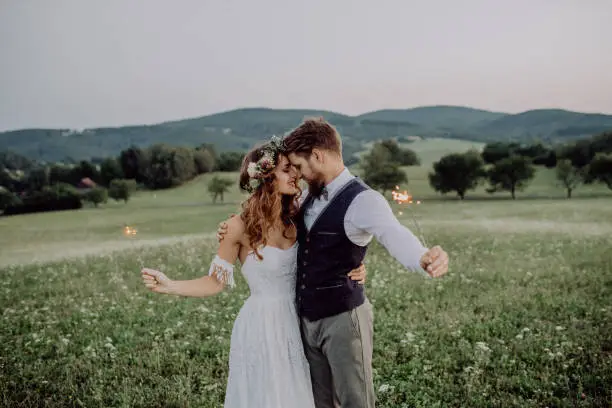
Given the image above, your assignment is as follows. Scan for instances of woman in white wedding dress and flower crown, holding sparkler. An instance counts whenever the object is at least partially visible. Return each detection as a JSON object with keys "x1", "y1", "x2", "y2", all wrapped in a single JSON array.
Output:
[{"x1": 141, "y1": 138, "x2": 365, "y2": 408}]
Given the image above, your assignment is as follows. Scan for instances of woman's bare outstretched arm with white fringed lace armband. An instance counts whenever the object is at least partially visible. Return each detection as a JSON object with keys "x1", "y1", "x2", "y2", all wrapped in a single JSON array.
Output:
[{"x1": 142, "y1": 217, "x2": 243, "y2": 297}]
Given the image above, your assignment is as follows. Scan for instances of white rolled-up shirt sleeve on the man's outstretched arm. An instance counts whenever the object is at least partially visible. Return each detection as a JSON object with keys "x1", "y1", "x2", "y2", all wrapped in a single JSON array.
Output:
[{"x1": 344, "y1": 190, "x2": 428, "y2": 273}]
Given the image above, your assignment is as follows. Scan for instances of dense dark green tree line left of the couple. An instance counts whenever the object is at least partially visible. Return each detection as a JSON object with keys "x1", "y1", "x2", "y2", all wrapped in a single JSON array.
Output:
[{"x1": 0, "y1": 144, "x2": 244, "y2": 215}]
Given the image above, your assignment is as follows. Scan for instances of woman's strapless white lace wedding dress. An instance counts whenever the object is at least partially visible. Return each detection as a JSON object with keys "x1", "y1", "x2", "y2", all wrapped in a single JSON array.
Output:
[{"x1": 224, "y1": 244, "x2": 314, "y2": 408}]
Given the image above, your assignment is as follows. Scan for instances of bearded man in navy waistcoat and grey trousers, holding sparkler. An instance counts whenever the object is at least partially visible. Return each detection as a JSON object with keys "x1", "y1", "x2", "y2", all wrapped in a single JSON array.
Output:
[{"x1": 218, "y1": 119, "x2": 448, "y2": 408}]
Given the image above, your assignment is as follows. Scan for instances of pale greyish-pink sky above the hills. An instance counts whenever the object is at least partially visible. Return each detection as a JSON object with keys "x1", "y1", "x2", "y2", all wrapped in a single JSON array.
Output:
[{"x1": 0, "y1": 0, "x2": 612, "y2": 130}]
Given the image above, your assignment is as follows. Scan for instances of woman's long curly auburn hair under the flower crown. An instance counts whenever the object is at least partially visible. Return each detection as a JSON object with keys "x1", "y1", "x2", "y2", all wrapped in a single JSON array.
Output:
[{"x1": 239, "y1": 145, "x2": 301, "y2": 260}]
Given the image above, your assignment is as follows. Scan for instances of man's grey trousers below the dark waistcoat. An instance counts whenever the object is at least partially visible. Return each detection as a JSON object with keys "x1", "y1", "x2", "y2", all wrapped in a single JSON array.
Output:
[{"x1": 301, "y1": 299, "x2": 375, "y2": 408}]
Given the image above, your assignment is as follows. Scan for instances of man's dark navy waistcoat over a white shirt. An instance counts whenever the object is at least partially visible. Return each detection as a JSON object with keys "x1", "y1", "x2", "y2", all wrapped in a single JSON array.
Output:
[{"x1": 296, "y1": 178, "x2": 369, "y2": 320}]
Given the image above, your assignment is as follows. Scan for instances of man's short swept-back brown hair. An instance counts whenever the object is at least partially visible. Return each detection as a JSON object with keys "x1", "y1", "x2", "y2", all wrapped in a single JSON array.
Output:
[{"x1": 283, "y1": 118, "x2": 342, "y2": 157}]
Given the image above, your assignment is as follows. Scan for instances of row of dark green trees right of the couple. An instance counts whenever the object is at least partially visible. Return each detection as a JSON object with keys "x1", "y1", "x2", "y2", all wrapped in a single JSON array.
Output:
[{"x1": 361, "y1": 132, "x2": 612, "y2": 199}]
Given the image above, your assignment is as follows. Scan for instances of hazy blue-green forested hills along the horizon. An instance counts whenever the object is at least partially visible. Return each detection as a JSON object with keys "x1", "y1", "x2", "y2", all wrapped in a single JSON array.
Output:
[{"x1": 0, "y1": 106, "x2": 612, "y2": 161}]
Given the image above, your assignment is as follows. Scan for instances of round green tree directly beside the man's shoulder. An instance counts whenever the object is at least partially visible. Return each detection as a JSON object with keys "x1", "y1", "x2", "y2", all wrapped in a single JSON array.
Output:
[{"x1": 361, "y1": 144, "x2": 408, "y2": 194}]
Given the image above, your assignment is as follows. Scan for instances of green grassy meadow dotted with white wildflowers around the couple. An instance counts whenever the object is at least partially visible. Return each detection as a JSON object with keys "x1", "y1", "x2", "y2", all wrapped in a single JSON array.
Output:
[{"x1": 0, "y1": 139, "x2": 612, "y2": 408}]
